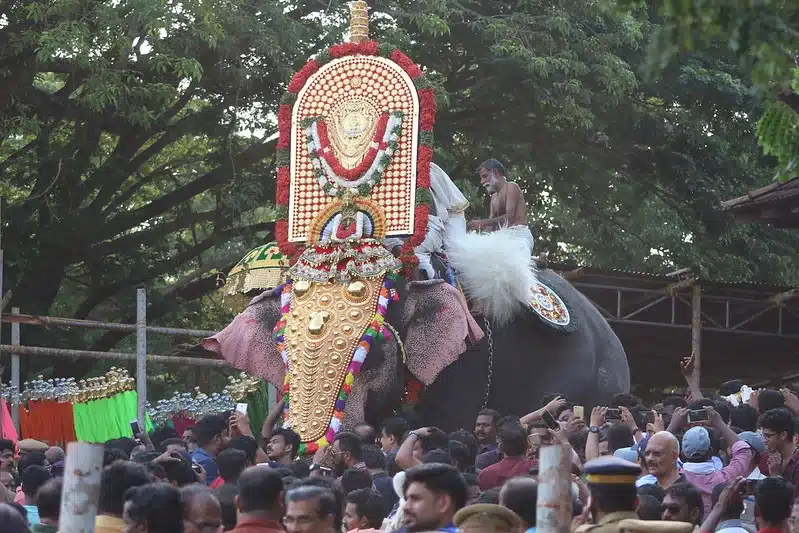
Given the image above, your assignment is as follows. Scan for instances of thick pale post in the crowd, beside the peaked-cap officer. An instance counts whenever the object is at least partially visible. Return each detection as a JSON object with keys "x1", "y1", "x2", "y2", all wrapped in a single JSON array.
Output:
[{"x1": 535, "y1": 445, "x2": 572, "y2": 533}]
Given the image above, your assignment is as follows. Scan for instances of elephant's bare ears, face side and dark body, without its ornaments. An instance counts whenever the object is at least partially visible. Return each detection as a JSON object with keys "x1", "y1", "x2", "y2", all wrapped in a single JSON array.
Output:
[{"x1": 202, "y1": 269, "x2": 630, "y2": 430}]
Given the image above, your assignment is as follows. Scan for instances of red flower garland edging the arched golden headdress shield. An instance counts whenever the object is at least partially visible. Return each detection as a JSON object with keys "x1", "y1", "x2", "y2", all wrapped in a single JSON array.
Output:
[{"x1": 275, "y1": 41, "x2": 437, "y2": 272}]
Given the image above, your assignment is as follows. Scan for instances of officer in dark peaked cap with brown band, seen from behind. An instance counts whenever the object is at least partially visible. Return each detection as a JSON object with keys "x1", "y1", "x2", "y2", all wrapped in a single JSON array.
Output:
[{"x1": 577, "y1": 456, "x2": 641, "y2": 533}]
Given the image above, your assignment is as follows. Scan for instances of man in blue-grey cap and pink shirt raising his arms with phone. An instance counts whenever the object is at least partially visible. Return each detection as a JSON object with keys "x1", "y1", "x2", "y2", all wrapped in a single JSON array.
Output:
[{"x1": 672, "y1": 407, "x2": 753, "y2": 515}]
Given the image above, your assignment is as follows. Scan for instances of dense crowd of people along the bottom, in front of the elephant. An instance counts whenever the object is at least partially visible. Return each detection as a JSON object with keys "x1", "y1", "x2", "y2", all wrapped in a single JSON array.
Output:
[{"x1": 0, "y1": 370, "x2": 799, "y2": 533}]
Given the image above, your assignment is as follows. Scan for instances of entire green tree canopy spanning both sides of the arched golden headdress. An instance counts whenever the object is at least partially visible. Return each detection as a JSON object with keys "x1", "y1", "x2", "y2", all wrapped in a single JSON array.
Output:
[{"x1": 0, "y1": 0, "x2": 797, "y2": 382}]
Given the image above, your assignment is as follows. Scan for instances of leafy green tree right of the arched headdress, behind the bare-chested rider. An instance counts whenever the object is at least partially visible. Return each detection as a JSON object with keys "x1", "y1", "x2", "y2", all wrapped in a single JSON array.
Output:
[{"x1": 380, "y1": 1, "x2": 797, "y2": 284}]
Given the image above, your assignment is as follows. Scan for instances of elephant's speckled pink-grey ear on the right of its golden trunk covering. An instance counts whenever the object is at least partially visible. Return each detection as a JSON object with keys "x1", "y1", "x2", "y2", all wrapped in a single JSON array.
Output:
[{"x1": 402, "y1": 280, "x2": 483, "y2": 385}]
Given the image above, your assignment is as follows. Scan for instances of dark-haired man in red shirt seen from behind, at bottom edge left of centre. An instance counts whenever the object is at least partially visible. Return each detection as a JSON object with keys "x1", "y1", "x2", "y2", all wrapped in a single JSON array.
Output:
[{"x1": 232, "y1": 466, "x2": 283, "y2": 533}]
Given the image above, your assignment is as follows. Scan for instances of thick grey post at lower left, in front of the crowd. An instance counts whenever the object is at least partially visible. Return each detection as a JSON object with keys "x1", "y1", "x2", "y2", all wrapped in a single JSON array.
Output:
[{"x1": 58, "y1": 442, "x2": 103, "y2": 533}]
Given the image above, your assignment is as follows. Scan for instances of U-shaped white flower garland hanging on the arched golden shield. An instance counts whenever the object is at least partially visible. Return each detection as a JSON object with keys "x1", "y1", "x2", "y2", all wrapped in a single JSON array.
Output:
[{"x1": 306, "y1": 111, "x2": 405, "y2": 197}]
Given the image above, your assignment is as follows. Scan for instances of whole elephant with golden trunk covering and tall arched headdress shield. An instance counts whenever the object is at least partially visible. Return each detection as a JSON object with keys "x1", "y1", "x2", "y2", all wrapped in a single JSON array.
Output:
[{"x1": 203, "y1": 4, "x2": 629, "y2": 453}]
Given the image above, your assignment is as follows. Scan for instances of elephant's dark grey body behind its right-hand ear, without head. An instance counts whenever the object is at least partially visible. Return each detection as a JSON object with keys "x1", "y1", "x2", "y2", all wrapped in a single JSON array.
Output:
[{"x1": 417, "y1": 269, "x2": 630, "y2": 428}]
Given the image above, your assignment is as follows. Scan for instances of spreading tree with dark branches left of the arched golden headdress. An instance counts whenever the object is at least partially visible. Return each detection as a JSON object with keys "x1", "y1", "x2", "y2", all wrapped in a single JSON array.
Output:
[{"x1": 0, "y1": 0, "x2": 326, "y2": 371}]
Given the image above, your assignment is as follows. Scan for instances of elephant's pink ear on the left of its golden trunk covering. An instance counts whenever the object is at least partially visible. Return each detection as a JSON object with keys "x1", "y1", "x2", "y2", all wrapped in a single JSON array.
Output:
[{"x1": 200, "y1": 289, "x2": 284, "y2": 390}]
